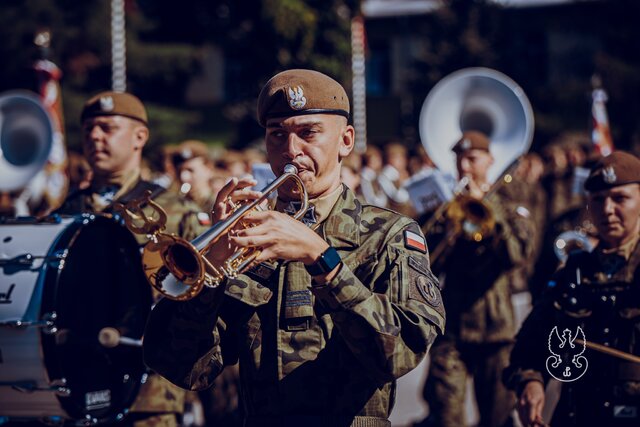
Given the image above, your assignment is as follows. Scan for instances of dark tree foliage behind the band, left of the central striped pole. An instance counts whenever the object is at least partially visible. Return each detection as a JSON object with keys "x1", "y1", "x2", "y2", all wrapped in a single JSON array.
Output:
[{"x1": 0, "y1": 0, "x2": 358, "y2": 154}]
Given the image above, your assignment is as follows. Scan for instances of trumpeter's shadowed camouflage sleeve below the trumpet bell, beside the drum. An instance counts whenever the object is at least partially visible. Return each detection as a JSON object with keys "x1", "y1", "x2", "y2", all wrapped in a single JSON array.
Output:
[{"x1": 143, "y1": 275, "x2": 273, "y2": 390}]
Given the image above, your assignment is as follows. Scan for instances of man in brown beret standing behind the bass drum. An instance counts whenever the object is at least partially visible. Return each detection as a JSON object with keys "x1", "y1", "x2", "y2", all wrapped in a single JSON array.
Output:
[{"x1": 56, "y1": 92, "x2": 208, "y2": 427}]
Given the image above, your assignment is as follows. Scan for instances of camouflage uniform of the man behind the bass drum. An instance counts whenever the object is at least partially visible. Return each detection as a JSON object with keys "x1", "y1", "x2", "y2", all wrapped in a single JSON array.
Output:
[{"x1": 56, "y1": 175, "x2": 206, "y2": 427}]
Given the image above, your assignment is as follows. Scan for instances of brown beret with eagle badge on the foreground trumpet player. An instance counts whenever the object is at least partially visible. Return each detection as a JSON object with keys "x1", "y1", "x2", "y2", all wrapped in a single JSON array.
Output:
[{"x1": 258, "y1": 70, "x2": 349, "y2": 127}]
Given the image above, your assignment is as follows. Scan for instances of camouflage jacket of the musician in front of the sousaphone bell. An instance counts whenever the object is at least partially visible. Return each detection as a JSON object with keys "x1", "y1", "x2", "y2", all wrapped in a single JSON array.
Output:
[{"x1": 425, "y1": 193, "x2": 533, "y2": 343}]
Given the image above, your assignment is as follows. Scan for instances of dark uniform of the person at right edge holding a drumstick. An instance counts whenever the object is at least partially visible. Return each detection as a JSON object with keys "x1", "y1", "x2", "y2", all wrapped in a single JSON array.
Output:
[{"x1": 505, "y1": 239, "x2": 640, "y2": 427}]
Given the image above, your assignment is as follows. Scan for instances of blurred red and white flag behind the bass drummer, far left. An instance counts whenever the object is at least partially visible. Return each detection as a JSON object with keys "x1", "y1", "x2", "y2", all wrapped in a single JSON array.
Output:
[{"x1": 31, "y1": 30, "x2": 69, "y2": 214}]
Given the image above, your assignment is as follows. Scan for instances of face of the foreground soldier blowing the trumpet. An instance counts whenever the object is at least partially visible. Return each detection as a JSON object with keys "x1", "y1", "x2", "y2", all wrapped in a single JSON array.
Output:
[{"x1": 265, "y1": 114, "x2": 354, "y2": 199}]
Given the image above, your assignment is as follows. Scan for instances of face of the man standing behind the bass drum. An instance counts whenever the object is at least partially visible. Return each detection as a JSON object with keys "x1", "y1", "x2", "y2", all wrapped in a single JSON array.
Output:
[{"x1": 82, "y1": 116, "x2": 149, "y2": 175}]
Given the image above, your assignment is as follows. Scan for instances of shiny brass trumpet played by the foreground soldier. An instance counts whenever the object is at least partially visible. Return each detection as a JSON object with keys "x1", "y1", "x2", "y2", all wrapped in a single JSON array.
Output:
[{"x1": 118, "y1": 164, "x2": 309, "y2": 301}]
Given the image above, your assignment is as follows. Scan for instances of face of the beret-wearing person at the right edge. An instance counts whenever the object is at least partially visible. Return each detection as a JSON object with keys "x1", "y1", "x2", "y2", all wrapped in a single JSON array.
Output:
[{"x1": 589, "y1": 184, "x2": 640, "y2": 247}]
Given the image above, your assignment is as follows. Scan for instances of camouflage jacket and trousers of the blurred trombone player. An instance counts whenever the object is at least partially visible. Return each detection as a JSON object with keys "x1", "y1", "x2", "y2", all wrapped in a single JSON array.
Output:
[{"x1": 424, "y1": 193, "x2": 531, "y2": 427}]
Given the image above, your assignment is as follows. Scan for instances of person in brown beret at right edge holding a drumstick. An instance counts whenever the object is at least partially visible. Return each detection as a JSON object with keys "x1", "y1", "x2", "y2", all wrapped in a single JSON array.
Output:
[{"x1": 505, "y1": 151, "x2": 640, "y2": 427}]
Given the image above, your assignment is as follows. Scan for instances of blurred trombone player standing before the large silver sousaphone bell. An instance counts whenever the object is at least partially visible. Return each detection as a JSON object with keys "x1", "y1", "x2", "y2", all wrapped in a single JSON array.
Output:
[{"x1": 424, "y1": 131, "x2": 530, "y2": 427}]
